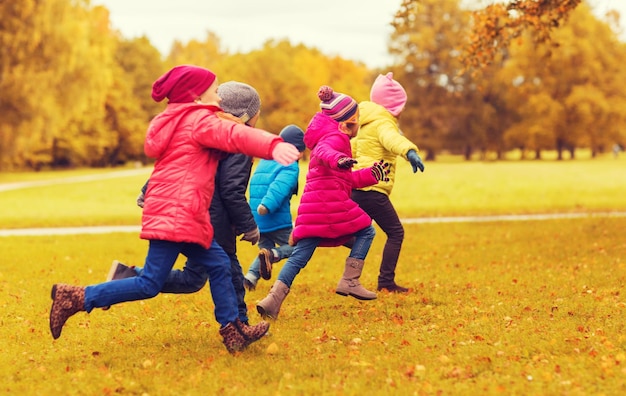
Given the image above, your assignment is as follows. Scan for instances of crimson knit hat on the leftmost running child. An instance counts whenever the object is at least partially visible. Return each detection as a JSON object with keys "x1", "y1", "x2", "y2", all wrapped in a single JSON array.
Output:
[{"x1": 152, "y1": 65, "x2": 215, "y2": 103}]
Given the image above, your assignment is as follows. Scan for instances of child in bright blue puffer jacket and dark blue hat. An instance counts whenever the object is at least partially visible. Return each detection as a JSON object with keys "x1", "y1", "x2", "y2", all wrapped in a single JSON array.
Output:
[{"x1": 244, "y1": 125, "x2": 306, "y2": 290}]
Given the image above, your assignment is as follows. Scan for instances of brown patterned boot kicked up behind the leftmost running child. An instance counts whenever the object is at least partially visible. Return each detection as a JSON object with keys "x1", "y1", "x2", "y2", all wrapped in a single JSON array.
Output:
[{"x1": 50, "y1": 283, "x2": 85, "y2": 340}]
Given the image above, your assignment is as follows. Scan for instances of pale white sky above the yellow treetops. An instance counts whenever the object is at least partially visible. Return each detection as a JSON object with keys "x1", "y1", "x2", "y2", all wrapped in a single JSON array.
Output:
[{"x1": 91, "y1": 0, "x2": 626, "y2": 68}]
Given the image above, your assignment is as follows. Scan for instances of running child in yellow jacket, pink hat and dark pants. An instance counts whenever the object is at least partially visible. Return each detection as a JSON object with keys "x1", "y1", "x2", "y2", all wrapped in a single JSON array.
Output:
[{"x1": 352, "y1": 73, "x2": 424, "y2": 293}]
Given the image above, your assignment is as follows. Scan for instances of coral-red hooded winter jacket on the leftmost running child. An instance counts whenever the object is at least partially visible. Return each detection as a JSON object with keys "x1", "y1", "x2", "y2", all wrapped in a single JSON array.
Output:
[{"x1": 141, "y1": 103, "x2": 282, "y2": 248}]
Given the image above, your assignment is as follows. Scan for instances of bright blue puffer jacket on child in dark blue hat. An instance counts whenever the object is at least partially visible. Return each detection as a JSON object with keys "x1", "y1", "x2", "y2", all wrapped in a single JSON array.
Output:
[{"x1": 249, "y1": 160, "x2": 300, "y2": 233}]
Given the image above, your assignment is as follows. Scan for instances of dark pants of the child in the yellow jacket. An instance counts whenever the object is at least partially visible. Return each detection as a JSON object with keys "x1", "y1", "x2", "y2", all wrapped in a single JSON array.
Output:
[{"x1": 352, "y1": 190, "x2": 404, "y2": 288}]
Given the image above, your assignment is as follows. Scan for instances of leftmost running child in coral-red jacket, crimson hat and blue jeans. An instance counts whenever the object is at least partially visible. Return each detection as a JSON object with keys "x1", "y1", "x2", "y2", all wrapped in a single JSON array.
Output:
[{"x1": 50, "y1": 65, "x2": 299, "y2": 353}]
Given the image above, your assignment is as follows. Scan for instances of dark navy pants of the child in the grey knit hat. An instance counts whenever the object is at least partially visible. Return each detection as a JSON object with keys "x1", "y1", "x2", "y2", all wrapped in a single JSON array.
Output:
[{"x1": 138, "y1": 253, "x2": 248, "y2": 323}]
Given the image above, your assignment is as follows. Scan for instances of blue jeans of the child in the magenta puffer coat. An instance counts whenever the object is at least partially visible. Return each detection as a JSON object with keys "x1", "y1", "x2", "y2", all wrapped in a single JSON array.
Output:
[{"x1": 278, "y1": 225, "x2": 376, "y2": 287}]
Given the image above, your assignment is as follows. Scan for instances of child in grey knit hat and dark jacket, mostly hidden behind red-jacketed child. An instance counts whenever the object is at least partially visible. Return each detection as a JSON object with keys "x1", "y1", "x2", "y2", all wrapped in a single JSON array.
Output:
[{"x1": 107, "y1": 81, "x2": 264, "y2": 324}]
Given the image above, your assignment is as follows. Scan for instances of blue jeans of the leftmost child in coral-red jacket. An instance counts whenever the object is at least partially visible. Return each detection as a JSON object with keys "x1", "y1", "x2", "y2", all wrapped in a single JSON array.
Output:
[{"x1": 85, "y1": 240, "x2": 237, "y2": 326}]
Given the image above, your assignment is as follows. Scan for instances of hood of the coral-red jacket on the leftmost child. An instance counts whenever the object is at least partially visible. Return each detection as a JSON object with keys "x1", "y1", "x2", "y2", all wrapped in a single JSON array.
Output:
[{"x1": 144, "y1": 103, "x2": 222, "y2": 158}]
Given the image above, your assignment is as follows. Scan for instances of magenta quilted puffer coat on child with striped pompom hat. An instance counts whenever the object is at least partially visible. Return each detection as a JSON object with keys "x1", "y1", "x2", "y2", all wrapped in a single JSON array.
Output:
[{"x1": 293, "y1": 113, "x2": 376, "y2": 246}]
